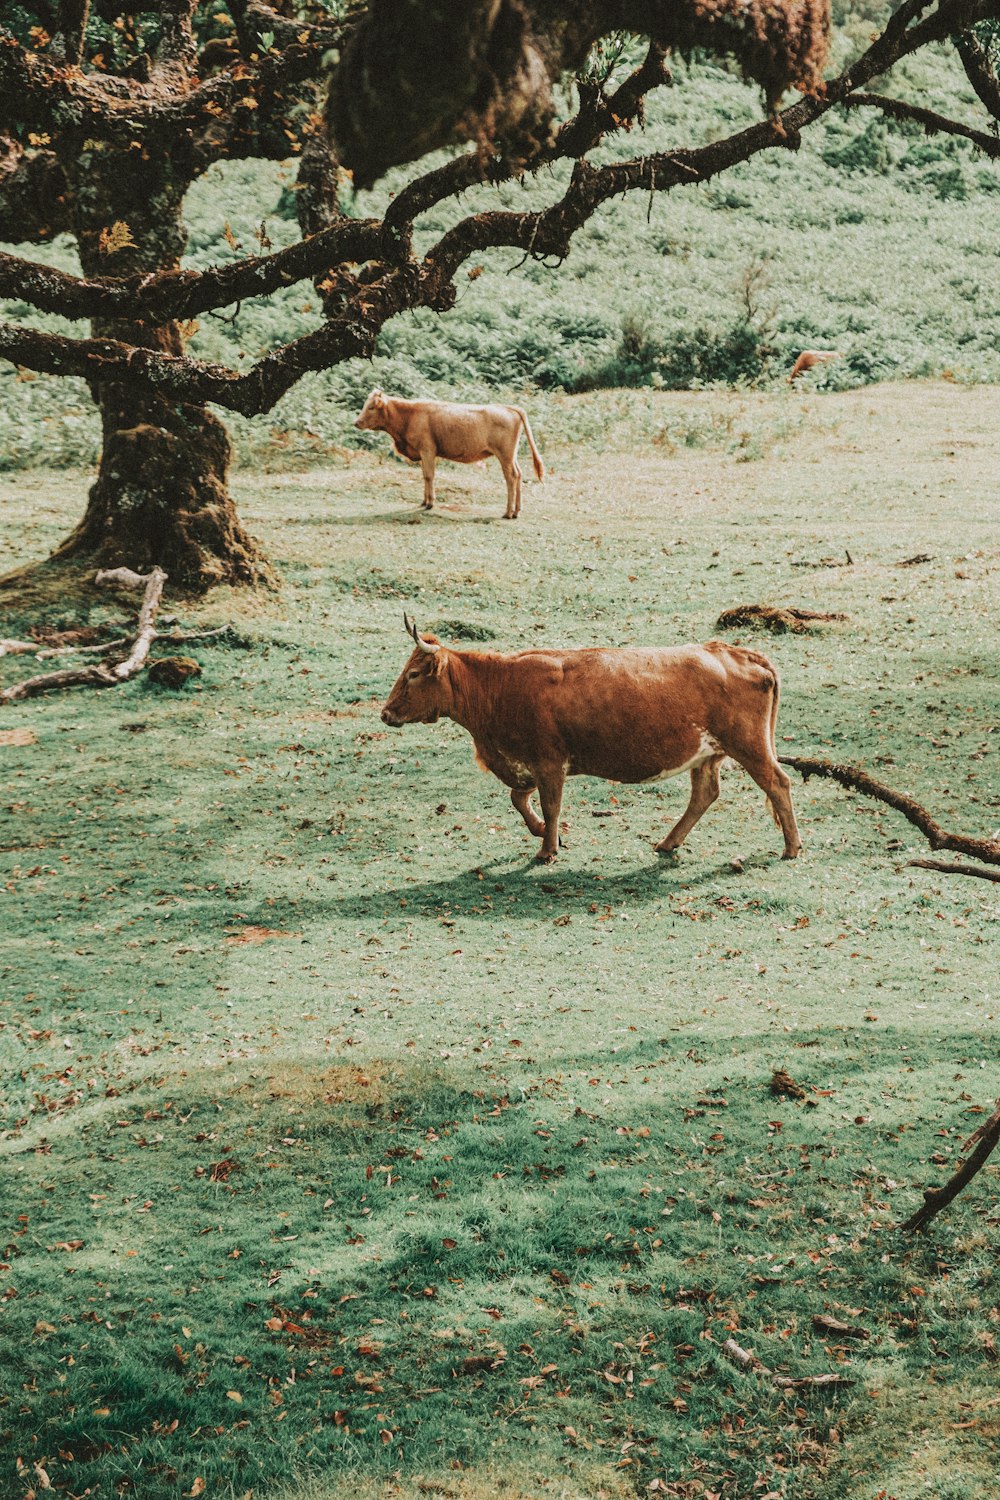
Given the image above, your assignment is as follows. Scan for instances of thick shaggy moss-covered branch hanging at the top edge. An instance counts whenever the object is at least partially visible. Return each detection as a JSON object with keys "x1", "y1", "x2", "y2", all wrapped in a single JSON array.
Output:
[{"x1": 328, "y1": 0, "x2": 829, "y2": 186}]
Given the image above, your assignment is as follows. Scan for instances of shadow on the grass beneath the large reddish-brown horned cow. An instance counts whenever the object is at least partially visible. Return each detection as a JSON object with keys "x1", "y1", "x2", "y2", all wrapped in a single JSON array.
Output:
[{"x1": 336, "y1": 854, "x2": 780, "y2": 921}]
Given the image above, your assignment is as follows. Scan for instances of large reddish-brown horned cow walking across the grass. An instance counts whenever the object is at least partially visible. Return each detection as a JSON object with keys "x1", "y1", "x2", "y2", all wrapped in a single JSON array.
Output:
[{"x1": 382, "y1": 617, "x2": 802, "y2": 864}]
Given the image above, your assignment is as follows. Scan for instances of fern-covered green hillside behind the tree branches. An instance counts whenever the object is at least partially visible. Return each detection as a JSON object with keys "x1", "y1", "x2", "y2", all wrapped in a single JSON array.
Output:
[{"x1": 0, "y1": 36, "x2": 1000, "y2": 470}]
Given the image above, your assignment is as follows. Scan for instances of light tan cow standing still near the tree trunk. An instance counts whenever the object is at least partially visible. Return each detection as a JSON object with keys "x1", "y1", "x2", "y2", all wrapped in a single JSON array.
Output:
[{"x1": 354, "y1": 386, "x2": 546, "y2": 521}]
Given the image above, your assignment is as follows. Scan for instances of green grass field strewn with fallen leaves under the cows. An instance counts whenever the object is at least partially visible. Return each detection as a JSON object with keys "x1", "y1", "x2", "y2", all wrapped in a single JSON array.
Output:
[{"x1": 0, "y1": 384, "x2": 1000, "y2": 1500}]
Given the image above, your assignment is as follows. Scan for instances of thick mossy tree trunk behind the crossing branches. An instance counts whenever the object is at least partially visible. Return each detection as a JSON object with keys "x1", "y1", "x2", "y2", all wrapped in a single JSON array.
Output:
[{"x1": 54, "y1": 152, "x2": 271, "y2": 593}]
